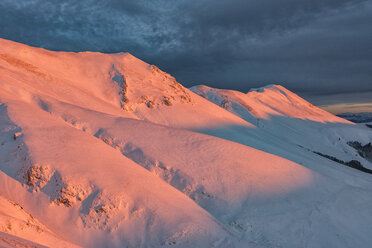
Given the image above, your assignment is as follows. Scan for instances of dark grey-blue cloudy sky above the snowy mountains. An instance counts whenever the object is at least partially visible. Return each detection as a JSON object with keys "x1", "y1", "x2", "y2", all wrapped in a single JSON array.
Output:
[{"x1": 0, "y1": 0, "x2": 372, "y2": 112}]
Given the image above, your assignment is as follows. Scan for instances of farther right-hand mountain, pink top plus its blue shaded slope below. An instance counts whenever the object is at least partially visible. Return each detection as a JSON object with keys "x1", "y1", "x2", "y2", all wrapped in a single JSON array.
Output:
[{"x1": 192, "y1": 85, "x2": 372, "y2": 169}]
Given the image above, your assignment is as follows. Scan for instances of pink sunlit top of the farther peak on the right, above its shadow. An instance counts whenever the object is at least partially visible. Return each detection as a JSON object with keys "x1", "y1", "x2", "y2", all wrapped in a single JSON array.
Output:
[{"x1": 191, "y1": 84, "x2": 349, "y2": 123}]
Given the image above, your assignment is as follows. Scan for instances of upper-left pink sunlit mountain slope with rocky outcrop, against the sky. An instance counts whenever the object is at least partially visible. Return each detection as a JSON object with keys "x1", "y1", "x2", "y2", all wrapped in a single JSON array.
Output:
[{"x1": 0, "y1": 39, "x2": 248, "y2": 131}]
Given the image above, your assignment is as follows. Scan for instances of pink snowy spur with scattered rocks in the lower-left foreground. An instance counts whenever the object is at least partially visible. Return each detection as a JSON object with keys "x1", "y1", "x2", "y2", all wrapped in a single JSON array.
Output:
[{"x1": 3, "y1": 102, "x2": 234, "y2": 247}]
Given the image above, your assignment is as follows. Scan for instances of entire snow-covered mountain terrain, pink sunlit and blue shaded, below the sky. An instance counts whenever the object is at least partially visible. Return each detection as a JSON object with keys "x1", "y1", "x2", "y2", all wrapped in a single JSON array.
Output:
[{"x1": 0, "y1": 39, "x2": 372, "y2": 247}]
